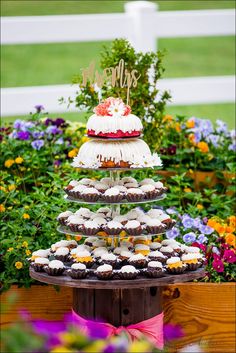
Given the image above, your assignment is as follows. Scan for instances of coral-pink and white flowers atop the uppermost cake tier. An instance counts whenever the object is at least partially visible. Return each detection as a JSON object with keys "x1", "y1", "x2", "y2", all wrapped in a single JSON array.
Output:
[{"x1": 93, "y1": 97, "x2": 131, "y2": 116}]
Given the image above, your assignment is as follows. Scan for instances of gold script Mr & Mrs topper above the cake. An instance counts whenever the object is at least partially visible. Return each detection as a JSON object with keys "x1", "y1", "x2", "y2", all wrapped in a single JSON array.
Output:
[{"x1": 82, "y1": 59, "x2": 141, "y2": 104}]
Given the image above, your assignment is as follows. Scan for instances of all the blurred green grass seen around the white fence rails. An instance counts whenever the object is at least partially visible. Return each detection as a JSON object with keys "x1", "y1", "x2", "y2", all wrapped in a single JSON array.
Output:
[{"x1": 1, "y1": 0, "x2": 235, "y2": 128}]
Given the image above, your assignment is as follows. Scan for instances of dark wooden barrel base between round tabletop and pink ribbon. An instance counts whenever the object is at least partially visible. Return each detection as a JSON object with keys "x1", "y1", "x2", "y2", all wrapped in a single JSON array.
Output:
[{"x1": 73, "y1": 287, "x2": 162, "y2": 326}]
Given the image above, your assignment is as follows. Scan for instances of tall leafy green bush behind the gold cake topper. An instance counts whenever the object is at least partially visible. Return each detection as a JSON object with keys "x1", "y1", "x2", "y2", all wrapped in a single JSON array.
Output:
[{"x1": 65, "y1": 39, "x2": 170, "y2": 150}]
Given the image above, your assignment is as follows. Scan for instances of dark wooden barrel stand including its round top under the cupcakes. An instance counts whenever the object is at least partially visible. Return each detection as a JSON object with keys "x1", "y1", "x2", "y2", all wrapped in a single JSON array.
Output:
[{"x1": 30, "y1": 268, "x2": 205, "y2": 326}]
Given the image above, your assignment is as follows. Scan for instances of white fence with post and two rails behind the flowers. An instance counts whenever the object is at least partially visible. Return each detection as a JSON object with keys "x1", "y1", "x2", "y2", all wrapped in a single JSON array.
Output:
[{"x1": 1, "y1": 1, "x2": 235, "y2": 116}]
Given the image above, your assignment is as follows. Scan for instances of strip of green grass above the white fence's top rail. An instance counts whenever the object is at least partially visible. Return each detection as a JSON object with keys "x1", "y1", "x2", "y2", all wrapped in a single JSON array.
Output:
[{"x1": 1, "y1": 0, "x2": 235, "y2": 16}]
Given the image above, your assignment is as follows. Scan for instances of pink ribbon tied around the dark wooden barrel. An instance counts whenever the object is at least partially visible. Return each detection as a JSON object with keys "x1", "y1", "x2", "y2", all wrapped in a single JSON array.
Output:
[{"x1": 72, "y1": 310, "x2": 164, "y2": 349}]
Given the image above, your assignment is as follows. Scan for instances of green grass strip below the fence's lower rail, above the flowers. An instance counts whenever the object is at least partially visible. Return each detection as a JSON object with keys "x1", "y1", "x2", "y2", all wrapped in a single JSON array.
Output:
[{"x1": 2, "y1": 104, "x2": 235, "y2": 129}]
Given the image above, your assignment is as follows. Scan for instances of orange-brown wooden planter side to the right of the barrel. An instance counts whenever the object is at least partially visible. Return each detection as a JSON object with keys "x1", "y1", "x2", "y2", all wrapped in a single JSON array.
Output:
[{"x1": 164, "y1": 283, "x2": 236, "y2": 353}]
